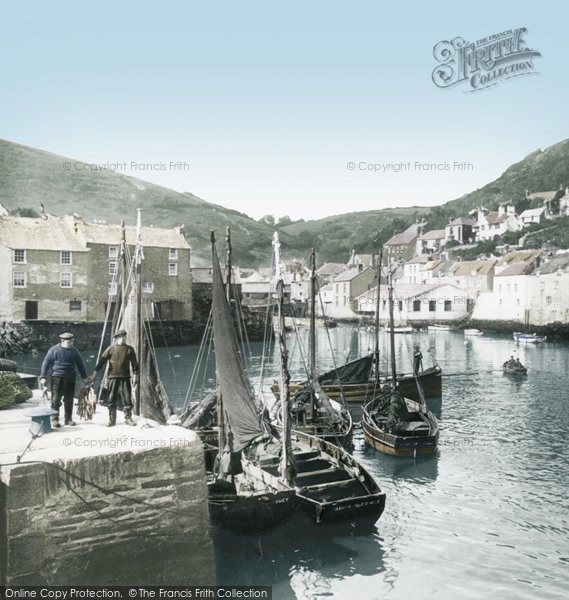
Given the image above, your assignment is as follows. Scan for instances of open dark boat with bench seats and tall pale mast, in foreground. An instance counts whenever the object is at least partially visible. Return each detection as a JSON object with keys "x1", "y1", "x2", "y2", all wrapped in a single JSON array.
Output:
[{"x1": 268, "y1": 233, "x2": 385, "y2": 526}]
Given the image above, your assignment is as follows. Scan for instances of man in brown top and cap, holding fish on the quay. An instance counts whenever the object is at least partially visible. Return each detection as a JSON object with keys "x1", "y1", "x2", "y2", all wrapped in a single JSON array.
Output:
[{"x1": 89, "y1": 329, "x2": 138, "y2": 427}]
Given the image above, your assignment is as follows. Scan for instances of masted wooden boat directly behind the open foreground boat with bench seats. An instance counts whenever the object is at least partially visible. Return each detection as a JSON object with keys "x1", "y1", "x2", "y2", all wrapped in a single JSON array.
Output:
[{"x1": 277, "y1": 248, "x2": 353, "y2": 449}]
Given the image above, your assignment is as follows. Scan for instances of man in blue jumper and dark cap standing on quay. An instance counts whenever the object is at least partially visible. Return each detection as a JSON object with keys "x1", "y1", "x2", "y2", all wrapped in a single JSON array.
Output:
[{"x1": 40, "y1": 332, "x2": 89, "y2": 427}]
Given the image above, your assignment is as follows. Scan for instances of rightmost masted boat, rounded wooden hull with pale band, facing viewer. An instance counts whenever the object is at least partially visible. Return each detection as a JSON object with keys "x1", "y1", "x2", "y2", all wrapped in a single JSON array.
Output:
[{"x1": 362, "y1": 264, "x2": 439, "y2": 456}]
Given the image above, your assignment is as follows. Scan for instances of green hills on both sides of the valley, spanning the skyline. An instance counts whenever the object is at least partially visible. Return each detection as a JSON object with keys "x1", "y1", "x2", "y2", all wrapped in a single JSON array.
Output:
[{"x1": 0, "y1": 140, "x2": 569, "y2": 266}]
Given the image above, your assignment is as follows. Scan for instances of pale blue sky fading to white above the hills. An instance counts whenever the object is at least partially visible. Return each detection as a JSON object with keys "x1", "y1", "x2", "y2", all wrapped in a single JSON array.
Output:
[{"x1": 0, "y1": 0, "x2": 569, "y2": 220}]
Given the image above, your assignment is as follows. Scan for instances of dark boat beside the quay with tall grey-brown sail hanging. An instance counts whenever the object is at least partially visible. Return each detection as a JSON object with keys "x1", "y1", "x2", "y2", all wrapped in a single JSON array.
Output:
[{"x1": 203, "y1": 232, "x2": 298, "y2": 533}]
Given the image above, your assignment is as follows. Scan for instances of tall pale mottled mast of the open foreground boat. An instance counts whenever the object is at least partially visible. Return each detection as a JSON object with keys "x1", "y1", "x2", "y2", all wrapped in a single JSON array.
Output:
[{"x1": 273, "y1": 231, "x2": 293, "y2": 484}]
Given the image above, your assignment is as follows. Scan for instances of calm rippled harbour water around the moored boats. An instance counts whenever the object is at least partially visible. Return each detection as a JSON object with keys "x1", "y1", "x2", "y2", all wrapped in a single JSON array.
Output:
[{"x1": 13, "y1": 327, "x2": 569, "y2": 600}]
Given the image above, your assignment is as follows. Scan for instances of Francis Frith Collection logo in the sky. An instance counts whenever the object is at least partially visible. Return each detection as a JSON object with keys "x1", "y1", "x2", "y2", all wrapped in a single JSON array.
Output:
[{"x1": 432, "y1": 27, "x2": 541, "y2": 92}]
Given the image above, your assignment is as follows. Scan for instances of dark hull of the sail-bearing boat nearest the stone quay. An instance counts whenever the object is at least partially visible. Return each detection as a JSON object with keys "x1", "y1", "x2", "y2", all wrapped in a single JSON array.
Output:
[{"x1": 209, "y1": 486, "x2": 299, "y2": 534}]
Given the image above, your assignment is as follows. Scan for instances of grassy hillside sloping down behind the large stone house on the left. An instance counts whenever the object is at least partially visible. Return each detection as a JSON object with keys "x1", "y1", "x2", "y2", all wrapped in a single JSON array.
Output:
[{"x1": 0, "y1": 140, "x2": 292, "y2": 266}]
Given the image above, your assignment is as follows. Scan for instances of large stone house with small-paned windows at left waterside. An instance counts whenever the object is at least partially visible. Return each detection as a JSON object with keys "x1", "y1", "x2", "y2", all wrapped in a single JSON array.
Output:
[{"x1": 0, "y1": 215, "x2": 192, "y2": 323}]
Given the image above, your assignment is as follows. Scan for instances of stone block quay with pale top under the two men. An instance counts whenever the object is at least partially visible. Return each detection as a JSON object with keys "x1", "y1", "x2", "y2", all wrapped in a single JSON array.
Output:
[{"x1": 0, "y1": 394, "x2": 215, "y2": 586}]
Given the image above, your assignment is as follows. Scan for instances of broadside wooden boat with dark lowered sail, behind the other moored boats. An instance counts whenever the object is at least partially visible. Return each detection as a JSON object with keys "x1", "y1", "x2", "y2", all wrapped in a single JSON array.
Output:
[{"x1": 271, "y1": 251, "x2": 442, "y2": 404}]
